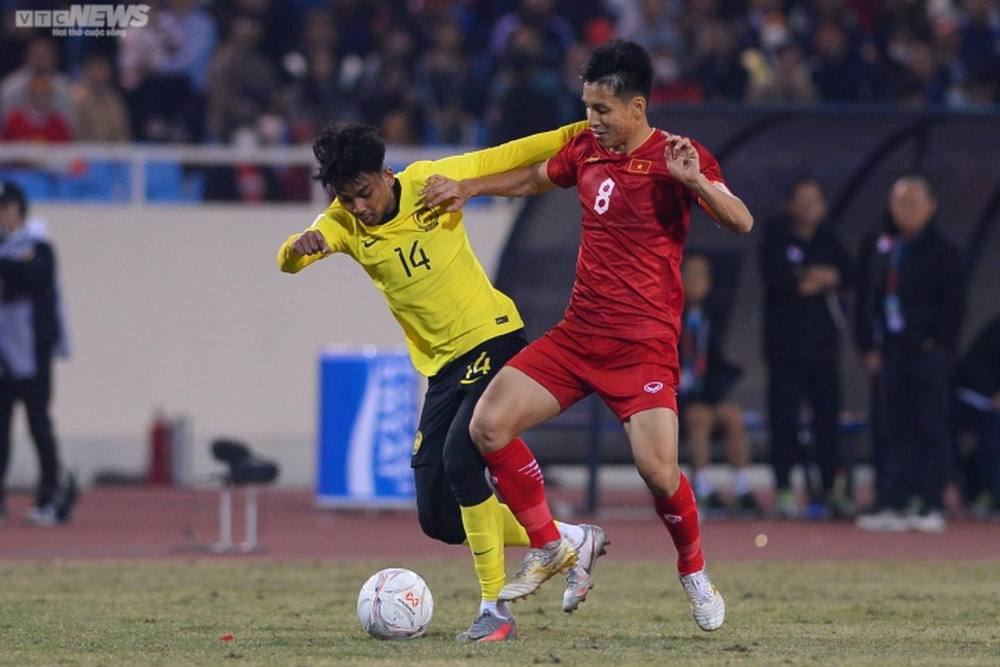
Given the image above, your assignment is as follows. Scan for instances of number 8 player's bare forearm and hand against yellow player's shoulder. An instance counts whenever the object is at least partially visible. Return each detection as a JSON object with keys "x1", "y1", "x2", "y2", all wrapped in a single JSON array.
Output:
[{"x1": 420, "y1": 160, "x2": 553, "y2": 212}]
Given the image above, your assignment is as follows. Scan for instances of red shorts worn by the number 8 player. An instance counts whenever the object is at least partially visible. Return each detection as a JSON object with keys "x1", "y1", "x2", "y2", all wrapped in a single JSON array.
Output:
[{"x1": 507, "y1": 321, "x2": 680, "y2": 421}]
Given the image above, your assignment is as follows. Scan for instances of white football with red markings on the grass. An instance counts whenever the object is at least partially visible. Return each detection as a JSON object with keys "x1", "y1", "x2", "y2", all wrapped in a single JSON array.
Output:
[{"x1": 358, "y1": 567, "x2": 434, "y2": 639}]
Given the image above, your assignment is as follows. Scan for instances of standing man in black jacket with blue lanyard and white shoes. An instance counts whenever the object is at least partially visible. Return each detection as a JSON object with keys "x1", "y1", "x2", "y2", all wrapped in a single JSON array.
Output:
[{"x1": 856, "y1": 174, "x2": 966, "y2": 532}]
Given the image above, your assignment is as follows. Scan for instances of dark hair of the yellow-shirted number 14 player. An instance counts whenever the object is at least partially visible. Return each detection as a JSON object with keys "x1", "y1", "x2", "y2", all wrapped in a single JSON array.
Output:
[{"x1": 313, "y1": 125, "x2": 385, "y2": 192}]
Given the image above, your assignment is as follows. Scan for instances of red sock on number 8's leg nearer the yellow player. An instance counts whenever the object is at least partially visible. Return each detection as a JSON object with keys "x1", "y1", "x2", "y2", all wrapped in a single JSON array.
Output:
[{"x1": 483, "y1": 438, "x2": 560, "y2": 548}]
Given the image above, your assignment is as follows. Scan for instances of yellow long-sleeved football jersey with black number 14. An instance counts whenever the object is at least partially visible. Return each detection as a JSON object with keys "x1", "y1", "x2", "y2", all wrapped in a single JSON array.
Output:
[{"x1": 278, "y1": 122, "x2": 586, "y2": 376}]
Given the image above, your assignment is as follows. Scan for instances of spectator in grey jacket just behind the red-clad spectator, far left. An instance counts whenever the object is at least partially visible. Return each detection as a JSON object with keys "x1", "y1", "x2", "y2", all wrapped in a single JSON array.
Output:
[{"x1": 0, "y1": 36, "x2": 74, "y2": 130}]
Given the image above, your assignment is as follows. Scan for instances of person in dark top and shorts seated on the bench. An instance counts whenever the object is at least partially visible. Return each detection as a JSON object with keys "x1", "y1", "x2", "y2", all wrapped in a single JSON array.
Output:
[{"x1": 677, "y1": 251, "x2": 758, "y2": 516}]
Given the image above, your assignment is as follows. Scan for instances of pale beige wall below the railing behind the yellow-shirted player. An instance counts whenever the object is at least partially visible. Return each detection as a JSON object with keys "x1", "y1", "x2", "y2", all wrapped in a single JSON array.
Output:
[{"x1": 8, "y1": 200, "x2": 517, "y2": 487}]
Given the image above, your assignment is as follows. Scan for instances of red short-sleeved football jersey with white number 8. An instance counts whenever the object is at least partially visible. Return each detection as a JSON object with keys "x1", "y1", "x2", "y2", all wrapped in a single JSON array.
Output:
[{"x1": 548, "y1": 130, "x2": 724, "y2": 341}]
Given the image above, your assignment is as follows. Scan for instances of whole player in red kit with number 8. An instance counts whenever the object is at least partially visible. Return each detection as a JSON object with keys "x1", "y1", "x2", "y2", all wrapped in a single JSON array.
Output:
[{"x1": 424, "y1": 40, "x2": 753, "y2": 631}]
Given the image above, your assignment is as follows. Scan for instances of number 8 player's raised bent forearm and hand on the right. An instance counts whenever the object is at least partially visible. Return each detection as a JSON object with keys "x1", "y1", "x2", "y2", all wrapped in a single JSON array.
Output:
[{"x1": 664, "y1": 133, "x2": 753, "y2": 234}]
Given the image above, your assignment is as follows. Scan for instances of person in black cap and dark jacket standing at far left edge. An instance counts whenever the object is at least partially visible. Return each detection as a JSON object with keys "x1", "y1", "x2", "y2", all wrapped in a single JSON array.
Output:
[{"x1": 0, "y1": 181, "x2": 76, "y2": 526}]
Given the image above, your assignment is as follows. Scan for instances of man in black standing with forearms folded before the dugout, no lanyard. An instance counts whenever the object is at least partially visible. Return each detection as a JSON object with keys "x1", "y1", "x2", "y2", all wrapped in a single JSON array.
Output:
[{"x1": 759, "y1": 177, "x2": 853, "y2": 518}]
